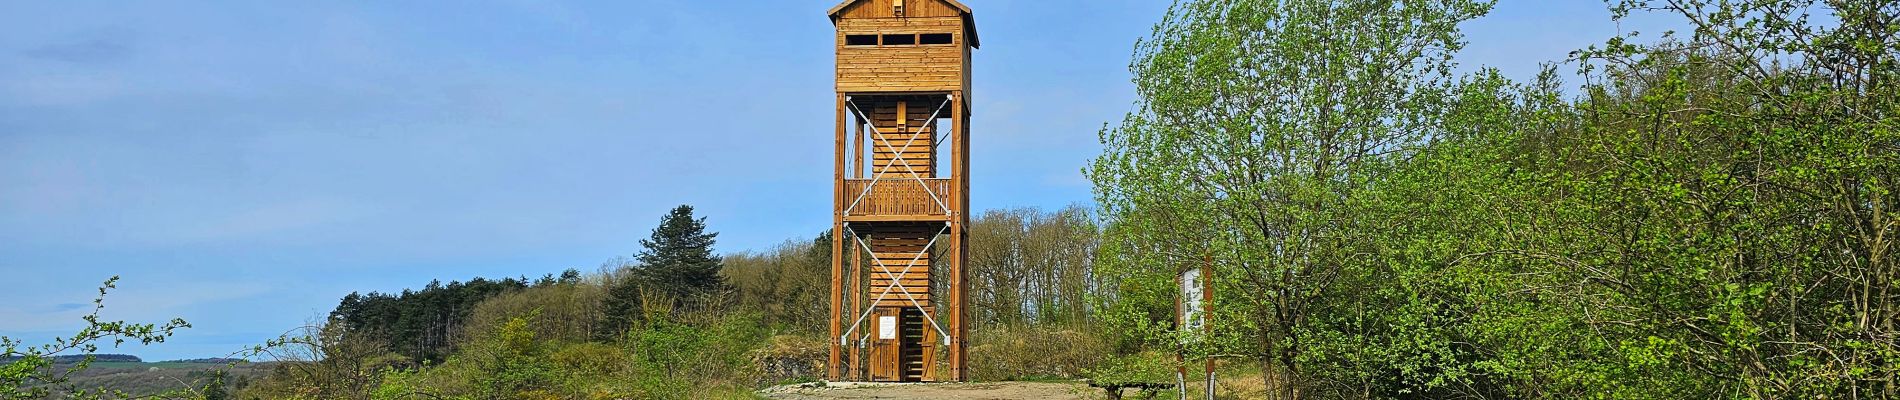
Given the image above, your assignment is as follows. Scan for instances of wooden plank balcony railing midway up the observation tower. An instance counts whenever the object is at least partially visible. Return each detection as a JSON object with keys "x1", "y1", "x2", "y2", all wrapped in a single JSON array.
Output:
[{"x1": 844, "y1": 176, "x2": 950, "y2": 222}]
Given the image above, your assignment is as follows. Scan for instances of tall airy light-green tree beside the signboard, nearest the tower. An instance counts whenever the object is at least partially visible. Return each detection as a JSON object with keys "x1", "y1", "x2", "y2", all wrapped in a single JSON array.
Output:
[{"x1": 1089, "y1": 0, "x2": 1490, "y2": 398}]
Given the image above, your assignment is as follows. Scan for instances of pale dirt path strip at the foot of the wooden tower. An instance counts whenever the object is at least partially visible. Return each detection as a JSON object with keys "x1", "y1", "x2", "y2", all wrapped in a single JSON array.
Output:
[{"x1": 758, "y1": 381, "x2": 1102, "y2": 400}]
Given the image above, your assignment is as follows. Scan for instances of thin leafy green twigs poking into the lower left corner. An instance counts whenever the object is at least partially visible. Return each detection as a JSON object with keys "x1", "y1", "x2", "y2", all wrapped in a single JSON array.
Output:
[{"x1": 0, "y1": 277, "x2": 192, "y2": 400}]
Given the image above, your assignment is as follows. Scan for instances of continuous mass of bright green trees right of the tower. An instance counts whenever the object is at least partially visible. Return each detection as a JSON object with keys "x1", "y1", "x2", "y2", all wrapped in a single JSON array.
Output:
[{"x1": 1091, "y1": 0, "x2": 1900, "y2": 398}]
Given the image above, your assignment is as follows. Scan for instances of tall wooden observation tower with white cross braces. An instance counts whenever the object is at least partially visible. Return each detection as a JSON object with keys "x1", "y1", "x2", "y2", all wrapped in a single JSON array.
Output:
[{"x1": 827, "y1": 0, "x2": 977, "y2": 381}]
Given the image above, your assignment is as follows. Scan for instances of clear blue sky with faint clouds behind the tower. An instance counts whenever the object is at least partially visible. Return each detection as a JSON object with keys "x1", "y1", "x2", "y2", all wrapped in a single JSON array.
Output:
[{"x1": 0, "y1": 0, "x2": 1679, "y2": 360}]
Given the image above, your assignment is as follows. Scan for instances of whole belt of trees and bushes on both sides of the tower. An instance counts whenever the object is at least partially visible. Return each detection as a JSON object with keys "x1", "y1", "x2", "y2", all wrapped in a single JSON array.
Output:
[{"x1": 0, "y1": 0, "x2": 1900, "y2": 400}]
